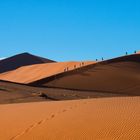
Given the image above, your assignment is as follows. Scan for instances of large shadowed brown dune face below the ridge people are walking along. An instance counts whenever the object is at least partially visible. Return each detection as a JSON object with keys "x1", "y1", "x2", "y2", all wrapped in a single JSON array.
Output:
[{"x1": 30, "y1": 54, "x2": 140, "y2": 95}]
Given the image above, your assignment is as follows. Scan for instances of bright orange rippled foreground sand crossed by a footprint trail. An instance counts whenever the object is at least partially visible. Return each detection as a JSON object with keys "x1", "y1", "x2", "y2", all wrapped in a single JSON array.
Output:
[{"x1": 0, "y1": 97, "x2": 140, "y2": 140}]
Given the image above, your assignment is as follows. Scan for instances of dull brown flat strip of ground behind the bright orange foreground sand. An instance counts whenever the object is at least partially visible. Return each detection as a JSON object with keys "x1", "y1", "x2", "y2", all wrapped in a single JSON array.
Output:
[{"x1": 0, "y1": 81, "x2": 119, "y2": 104}]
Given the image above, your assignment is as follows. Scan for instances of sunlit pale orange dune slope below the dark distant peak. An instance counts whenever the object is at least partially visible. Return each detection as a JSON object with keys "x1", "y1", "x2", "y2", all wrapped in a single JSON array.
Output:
[{"x1": 0, "y1": 61, "x2": 95, "y2": 84}]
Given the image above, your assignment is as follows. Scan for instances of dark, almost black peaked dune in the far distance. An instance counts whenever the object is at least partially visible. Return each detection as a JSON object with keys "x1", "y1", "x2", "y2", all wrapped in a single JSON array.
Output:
[{"x1": 0, "y1": 53, "x2": 54, "y2": 73}]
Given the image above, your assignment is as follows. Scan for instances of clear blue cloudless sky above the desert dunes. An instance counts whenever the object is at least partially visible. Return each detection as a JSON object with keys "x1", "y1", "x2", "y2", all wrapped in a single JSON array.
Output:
[{"x1": 0, "y1": 0, "x2": 140, "y2": 61}]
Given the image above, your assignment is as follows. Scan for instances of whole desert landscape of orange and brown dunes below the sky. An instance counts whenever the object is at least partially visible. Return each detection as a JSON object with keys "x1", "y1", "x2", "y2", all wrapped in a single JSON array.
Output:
[{"x1": 0, "y1": 53, "x2": 140, "y2": 140}]
